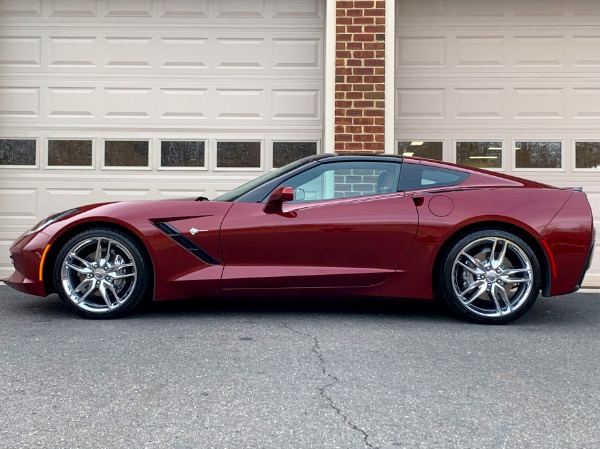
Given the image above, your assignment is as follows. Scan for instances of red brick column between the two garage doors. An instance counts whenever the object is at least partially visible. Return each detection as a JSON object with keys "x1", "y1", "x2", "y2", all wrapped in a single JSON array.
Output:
[{"x1": 330, "y1": 0, "x2": 385, "y2": 153}]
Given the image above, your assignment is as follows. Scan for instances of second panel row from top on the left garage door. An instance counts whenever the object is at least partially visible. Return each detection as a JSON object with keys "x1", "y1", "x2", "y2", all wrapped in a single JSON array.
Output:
[{"x1": 0, "y1": 30, "x2": 323, "y2": 77}]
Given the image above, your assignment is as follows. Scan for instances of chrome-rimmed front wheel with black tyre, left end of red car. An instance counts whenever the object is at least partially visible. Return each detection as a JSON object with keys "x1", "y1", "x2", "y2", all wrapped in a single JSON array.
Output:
[{"x1": 54, "y1": 228, "x2": 149, "y2": 318}]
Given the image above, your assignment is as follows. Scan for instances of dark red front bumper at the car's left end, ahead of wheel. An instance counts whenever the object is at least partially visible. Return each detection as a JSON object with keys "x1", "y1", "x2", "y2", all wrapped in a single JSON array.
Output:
[{"x1": 2, "y1": 232, "x2": 50, "y2": 296}]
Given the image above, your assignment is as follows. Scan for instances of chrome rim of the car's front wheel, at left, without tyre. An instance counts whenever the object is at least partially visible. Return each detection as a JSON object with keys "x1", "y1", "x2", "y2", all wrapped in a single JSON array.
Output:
[{"x1": 61, "y1": 237, "x2": 137, "y2": 313}]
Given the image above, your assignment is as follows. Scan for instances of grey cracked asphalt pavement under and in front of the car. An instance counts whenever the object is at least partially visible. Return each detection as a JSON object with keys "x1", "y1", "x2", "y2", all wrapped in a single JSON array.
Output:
[{"x1": 0, "y1": 286, "x2": 600, "y2": 449}]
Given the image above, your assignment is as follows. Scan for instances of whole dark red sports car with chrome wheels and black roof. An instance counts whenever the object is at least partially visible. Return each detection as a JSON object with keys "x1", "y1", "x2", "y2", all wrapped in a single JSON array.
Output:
[{"x1": 4, "y1": 155, "x2": 595, "y2": 324}]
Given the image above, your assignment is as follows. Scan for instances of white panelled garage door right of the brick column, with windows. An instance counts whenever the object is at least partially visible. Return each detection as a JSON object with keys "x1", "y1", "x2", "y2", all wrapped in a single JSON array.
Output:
[{"x1": 395, "y1": 0, "x2": 600, "y2": 286}]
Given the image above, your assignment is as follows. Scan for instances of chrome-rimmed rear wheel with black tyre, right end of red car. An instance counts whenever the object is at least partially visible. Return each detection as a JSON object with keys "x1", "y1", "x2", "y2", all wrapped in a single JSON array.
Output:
[{"x1": 441, "y1": 229, "x2": 541, "y2": 324}]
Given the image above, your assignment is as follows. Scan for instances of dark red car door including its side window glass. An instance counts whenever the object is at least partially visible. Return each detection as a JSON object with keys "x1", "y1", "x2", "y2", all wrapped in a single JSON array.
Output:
[{"x1": 221, "y1": 161, "x2": 418, "y2": 289}]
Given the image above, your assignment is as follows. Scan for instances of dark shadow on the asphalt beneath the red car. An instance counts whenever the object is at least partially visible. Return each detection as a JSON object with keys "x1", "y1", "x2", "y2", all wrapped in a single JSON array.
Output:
[{"x1": 0, "y1": 287, "x2": 600, "y2": 326}]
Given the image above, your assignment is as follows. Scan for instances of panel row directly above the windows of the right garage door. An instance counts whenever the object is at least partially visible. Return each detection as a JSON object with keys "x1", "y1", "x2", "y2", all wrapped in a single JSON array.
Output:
[{"x1": 395, "y1": 81, "x2": 600, "y2": 125}]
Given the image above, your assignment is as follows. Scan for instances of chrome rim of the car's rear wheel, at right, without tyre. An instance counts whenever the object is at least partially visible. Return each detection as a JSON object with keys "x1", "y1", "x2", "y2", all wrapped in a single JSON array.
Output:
[{"x1": 452, "y1": 237, "x2": 534, "y2": 317}]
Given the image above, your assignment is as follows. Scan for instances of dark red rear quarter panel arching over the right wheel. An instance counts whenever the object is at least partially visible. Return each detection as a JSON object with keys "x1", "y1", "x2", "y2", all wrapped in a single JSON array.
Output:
[{"x1": 394, "y1": 187, "x2": 573, "y2": 298}]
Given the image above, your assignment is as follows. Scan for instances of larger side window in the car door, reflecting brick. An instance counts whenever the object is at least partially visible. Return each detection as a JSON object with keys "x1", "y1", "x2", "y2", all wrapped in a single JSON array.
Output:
[{"x1": 281, "y1": 161, "x2": 401, "y2": 203}]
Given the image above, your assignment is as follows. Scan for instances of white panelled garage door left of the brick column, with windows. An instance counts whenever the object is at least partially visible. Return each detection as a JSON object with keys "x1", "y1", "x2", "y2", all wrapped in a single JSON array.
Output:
[{"x1": 0, "y1": 0, "x2": 324, "y2": 276}]
